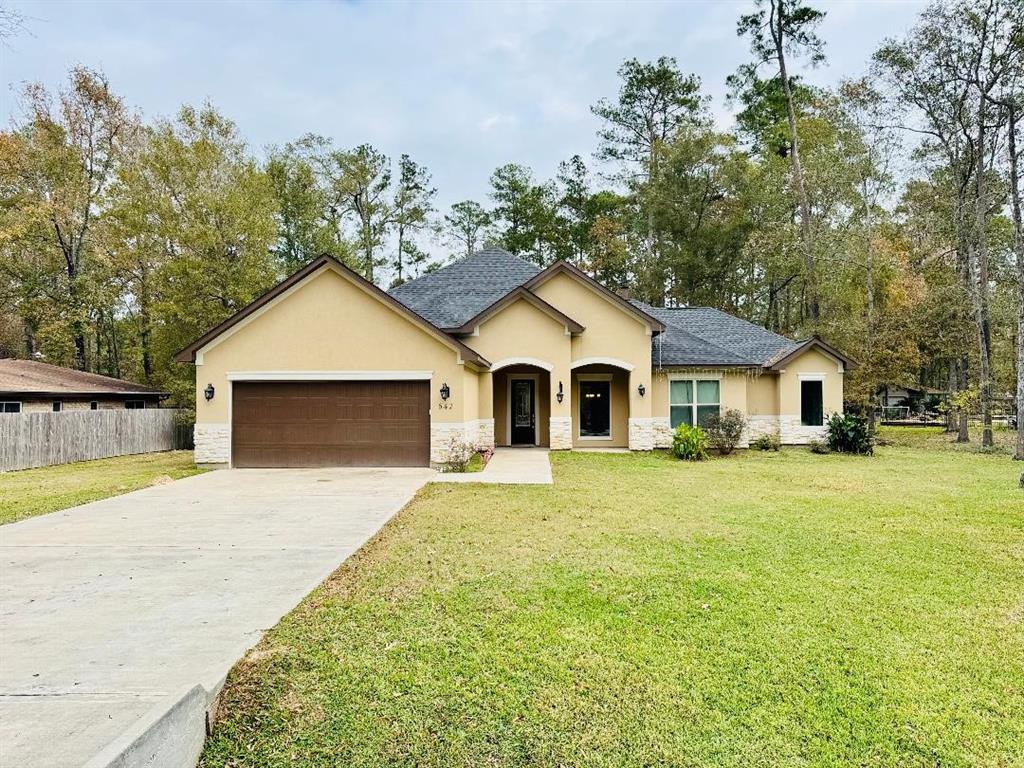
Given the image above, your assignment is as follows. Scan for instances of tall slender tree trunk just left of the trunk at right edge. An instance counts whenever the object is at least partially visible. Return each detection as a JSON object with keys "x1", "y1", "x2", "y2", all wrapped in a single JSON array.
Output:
[{"x1": 972, "y1": 104, "x2": 992, "y2": 446}]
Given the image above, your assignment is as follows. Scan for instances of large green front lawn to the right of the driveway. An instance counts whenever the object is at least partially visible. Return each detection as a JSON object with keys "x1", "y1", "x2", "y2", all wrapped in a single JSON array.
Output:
[{"x1": 202, "y1": 447, "x2": 1024, "y2": 768}]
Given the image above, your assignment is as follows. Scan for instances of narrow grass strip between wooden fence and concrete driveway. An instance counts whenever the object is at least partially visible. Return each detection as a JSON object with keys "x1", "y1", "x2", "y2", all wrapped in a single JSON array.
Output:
[{"x1": 0, "y1": 451, "x2": 204, "y2": 525}]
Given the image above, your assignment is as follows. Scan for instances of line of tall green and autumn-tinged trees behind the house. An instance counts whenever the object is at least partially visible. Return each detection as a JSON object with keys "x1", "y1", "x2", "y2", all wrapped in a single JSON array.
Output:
[{"x1": 0, "y1": 0, "x2": 1024, "y2": 456}]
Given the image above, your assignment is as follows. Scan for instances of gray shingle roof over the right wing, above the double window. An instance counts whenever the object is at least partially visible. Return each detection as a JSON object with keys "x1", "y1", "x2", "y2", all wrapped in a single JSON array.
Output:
[{"x1": 634, "y1": 302, "x2": 799, "y2": 366}]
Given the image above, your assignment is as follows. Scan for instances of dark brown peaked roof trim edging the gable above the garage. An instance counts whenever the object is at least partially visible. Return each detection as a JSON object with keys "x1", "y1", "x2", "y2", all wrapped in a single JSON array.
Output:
[{"x1": 175, "y1": 254, "x2": 489, "y2": 368}]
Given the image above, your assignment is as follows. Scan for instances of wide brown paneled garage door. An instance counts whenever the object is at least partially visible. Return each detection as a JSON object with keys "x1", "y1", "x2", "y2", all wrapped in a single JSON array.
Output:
[{"x1": 231, "y1": 381, "x2": 430, "y2": 467}]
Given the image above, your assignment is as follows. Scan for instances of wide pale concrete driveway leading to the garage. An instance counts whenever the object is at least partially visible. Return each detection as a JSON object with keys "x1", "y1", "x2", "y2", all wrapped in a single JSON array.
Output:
[{"x1": 0, "y1": 469, "x2": 436, "y2": 768}]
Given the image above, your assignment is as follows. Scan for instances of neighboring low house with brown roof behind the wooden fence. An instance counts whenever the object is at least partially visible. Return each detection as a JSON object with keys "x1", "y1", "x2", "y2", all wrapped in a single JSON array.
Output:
[{"x1": 0, "y1": 358, "x2": 167, "y2": 414}]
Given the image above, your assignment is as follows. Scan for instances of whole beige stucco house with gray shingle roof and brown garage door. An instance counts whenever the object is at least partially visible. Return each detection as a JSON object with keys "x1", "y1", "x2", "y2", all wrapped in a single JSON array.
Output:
[{"x1": 177, "y1": 249, "x2": 852, "y2": 467}]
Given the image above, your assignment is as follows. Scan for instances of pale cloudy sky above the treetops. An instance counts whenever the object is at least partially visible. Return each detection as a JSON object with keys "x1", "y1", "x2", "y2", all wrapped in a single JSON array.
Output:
[{"x1": 0, "y1": 0, "x2": 925, "y2": 217}]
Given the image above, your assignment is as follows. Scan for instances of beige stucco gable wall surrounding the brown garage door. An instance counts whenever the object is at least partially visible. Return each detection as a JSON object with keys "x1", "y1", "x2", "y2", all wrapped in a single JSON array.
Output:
[{"x1": 196, "y1": 267, "x2": 479, "y2": 425}]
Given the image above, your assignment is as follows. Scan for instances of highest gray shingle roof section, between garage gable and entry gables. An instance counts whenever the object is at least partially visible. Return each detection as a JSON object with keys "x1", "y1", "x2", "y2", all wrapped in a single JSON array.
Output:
[{"x1": 389, "y1": 248, "x2": 541, "y2": 328}]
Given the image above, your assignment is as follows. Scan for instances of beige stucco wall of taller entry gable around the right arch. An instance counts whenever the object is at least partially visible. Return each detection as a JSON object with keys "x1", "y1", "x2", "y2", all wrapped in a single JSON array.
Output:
[{"x1": 534, "y1": 273, "x2": 651, "y2": 428}]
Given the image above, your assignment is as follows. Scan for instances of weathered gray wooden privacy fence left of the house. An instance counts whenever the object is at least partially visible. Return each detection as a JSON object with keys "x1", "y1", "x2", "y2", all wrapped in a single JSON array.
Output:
[{"x1": 0, "y1": 409, "x2": 190, "y2": 472}]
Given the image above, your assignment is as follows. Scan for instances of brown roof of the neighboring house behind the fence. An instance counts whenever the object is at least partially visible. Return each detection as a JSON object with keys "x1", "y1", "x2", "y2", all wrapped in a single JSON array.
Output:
[{"x1": 0, "y1": 358, "x2": 167, "y2": 397}]
